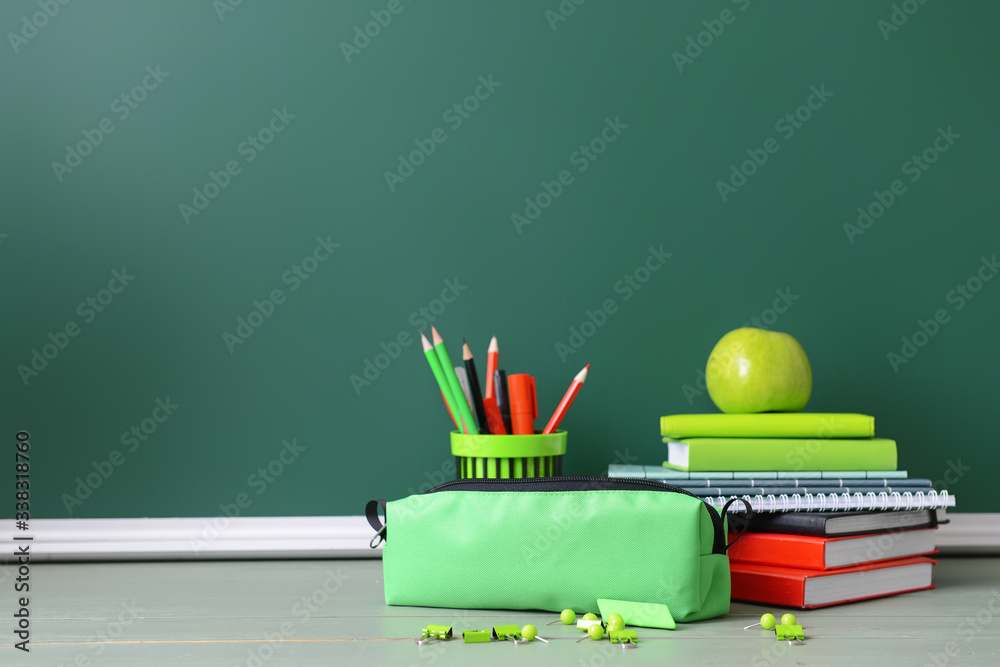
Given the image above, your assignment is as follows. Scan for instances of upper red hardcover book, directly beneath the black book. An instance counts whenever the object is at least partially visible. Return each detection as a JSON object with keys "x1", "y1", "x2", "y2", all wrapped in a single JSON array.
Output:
[{"x1": 729, "y1": 528, "x2": 937, "y2": 570}]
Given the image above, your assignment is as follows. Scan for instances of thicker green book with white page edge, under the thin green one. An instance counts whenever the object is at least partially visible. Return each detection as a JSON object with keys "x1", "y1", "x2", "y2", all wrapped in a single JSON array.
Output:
[{"x1": 663, "y1": 438, "x2": 896, "y2": 472}]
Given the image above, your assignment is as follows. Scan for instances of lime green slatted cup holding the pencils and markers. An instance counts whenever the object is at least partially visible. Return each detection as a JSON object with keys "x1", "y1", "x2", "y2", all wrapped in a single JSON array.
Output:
[{"x1": 451, "y1": 431, "x2": 566, "y2": 479}]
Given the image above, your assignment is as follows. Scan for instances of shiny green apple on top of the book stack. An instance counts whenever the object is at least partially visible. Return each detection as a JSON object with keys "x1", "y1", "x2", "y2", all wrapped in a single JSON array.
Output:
[{"x1": 705, "y1": 327, "x2": 812, "y2": 413}]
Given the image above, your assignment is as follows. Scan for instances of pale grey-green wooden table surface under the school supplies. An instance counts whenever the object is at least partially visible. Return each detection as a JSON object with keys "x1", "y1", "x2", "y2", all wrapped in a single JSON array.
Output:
[{"x1": 0, "y1": 557, "x2": 1000, "y2": 667}]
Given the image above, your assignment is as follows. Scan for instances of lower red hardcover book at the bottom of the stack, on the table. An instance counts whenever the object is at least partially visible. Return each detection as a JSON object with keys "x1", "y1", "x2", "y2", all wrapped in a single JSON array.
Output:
[{"x1": 729, "y1": 557, "x2": 936, "y2": 609}]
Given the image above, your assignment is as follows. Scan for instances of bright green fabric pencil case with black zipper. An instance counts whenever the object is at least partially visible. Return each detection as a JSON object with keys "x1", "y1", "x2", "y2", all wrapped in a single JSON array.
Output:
[{"x1": 366, "y1": 477, "x2": 750, "y2": 622}]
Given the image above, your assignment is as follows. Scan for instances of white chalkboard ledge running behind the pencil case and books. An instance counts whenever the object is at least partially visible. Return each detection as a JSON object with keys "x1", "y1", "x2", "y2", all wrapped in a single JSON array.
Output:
[{"x1": 0, "y1": 512, "x2": 1000, "y2": 563}]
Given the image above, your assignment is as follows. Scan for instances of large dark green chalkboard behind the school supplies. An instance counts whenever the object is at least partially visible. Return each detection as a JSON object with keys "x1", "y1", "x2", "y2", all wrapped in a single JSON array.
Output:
[{"x1": 0, "y1": 0, "x2": 1000, "y2": 518}]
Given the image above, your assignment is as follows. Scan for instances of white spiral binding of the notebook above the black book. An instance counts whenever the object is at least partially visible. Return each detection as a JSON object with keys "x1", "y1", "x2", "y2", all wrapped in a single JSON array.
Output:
[{"x1": 703, "y1": 489, "x2": 955, "y2": 512}]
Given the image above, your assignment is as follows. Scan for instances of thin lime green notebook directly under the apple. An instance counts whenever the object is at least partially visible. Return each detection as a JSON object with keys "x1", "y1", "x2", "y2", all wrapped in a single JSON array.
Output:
[{"x1": 660, "y1": 412, "x2": 875, "y2": 440}]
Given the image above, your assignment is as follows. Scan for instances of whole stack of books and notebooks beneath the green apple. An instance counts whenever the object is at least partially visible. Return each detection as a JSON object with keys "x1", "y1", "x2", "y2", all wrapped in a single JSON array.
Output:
[{"x1": 608, "y1": 413, "x2": 954, "y2": 608}]
